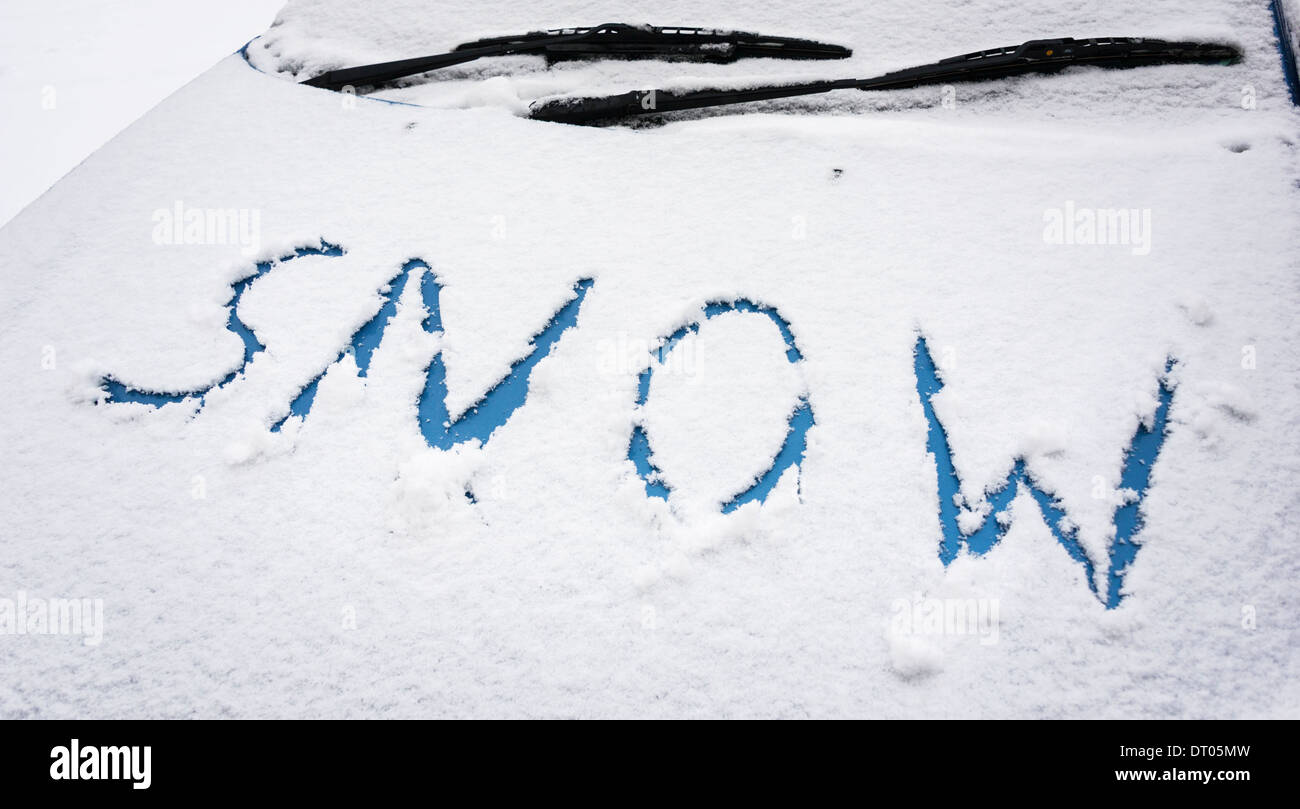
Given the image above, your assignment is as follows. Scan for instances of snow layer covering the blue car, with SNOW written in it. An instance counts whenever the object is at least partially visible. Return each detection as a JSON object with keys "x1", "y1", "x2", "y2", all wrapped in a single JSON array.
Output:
[{"x1": 0, "y1": 0, "x2": 1300, "y2": 717}]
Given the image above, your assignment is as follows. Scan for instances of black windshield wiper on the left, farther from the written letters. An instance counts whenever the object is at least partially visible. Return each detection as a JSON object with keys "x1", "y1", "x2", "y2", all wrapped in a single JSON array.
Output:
[{"x1": 302, "y1": 22, "x2": 853, "y2": 90}]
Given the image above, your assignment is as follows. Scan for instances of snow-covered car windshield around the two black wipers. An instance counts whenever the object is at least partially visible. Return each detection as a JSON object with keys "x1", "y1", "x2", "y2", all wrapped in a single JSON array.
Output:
[{"x1": 246, "y1": 0, "x2": 1262, "y2": 126}]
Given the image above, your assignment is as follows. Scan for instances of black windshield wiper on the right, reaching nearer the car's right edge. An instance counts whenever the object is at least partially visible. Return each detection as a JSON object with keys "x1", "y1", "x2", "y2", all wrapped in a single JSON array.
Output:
[{"x1": 529, "y1": 38, "x2": 1242, "y2": 124}]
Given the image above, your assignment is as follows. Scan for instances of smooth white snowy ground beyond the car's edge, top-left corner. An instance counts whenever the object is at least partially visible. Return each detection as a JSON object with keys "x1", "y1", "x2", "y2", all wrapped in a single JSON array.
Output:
[{"x1": 0, "y1": 0, "x2": 282, "y2": 224}]
